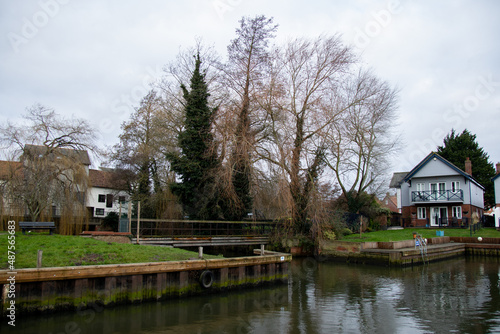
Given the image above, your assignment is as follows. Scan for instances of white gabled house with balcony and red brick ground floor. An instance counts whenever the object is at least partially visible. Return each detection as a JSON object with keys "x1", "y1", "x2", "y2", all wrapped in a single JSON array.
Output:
[{"x1": 391, "y1": 152, "x2": 484, "y2": 227}]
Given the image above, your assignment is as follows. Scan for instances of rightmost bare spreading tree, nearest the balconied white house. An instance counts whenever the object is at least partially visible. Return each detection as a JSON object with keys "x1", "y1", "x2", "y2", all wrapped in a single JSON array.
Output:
[{"x1": 324, "y1": 71, "x2": 398, "y2": 207}]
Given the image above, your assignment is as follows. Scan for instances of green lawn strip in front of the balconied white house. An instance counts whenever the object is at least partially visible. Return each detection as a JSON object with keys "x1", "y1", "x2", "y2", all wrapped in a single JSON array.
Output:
[{"x1": 342, "y1": 228, "x2": 500, "y2": 242}]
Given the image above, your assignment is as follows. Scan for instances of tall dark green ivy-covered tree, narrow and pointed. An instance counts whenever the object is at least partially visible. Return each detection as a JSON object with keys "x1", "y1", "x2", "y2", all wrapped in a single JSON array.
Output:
[{"x1": 167, "y1": 54, "x2": 221, "y2": 219}]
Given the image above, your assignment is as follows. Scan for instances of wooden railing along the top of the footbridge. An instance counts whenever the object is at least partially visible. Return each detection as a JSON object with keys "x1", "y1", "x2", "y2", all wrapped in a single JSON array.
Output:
[{"x1": 130, "y1": 219, "x2": 280, "y2": 238}]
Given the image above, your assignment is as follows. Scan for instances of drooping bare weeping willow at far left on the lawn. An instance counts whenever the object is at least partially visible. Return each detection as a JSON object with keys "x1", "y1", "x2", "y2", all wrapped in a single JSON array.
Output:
[{"x1": 0, "y1": 105, "x2": 97, "y2": 234}]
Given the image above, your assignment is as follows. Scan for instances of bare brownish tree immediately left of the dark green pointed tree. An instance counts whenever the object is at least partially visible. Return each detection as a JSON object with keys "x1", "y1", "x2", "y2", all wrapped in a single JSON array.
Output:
[{"x1": 111, "y1": 90, "x2": 181, "y2": 218}]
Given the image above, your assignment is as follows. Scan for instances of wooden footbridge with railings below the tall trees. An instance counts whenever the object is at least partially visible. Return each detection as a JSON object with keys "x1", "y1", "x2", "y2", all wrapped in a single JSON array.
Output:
[{"x1": 124, "y1": 219, "x2": 281, "y2": 247}]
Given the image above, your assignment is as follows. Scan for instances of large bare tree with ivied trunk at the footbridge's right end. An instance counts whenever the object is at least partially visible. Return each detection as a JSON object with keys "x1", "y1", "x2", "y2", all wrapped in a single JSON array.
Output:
[{"x1": 259, "y1": 36, "x2": 355, "y2": 232}]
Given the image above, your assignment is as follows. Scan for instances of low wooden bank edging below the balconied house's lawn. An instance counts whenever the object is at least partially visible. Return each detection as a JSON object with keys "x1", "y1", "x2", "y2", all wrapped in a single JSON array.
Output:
[{"x1": 319, "y1": 237, "x2": 500, "y2": 266}]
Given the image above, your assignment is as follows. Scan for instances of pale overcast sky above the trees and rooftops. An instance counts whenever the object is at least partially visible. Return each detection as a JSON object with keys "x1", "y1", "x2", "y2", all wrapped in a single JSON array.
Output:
[{"x1": 0, "y1": 0, "x2": 500, "y2": 177}]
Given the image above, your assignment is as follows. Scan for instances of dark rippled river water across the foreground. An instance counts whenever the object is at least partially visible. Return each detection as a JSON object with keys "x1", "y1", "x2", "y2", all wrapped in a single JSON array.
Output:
[{"x1": 0, "y1": 258, "x2": 500, "y2": 334}]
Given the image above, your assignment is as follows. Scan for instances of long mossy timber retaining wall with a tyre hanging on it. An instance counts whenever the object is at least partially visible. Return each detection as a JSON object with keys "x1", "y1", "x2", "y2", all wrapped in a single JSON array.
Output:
[{"x1": 0, "y1": 251, "x2": 292, "y2": 314}]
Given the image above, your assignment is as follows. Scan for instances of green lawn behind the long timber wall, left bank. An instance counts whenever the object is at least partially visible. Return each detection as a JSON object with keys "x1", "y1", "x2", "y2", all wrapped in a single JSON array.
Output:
[{"x1": 0, "y1": 233, "x2": 223, "y2": 269}]
